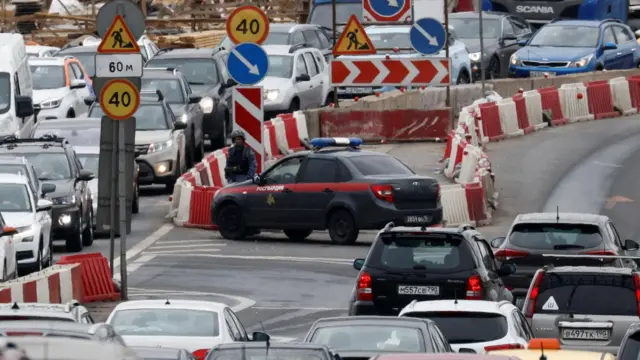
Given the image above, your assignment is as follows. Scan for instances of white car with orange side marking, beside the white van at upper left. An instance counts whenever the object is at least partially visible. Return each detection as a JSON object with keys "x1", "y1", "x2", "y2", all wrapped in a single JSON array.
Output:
[{"x1": 29, "y1": 57, "x2": 91, "y2": 120}]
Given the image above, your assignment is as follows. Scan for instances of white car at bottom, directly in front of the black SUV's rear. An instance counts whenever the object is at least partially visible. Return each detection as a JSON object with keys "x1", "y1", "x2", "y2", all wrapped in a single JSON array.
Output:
[{"x1": 398, "y1": 300, "x2": 533, "y2": 354}]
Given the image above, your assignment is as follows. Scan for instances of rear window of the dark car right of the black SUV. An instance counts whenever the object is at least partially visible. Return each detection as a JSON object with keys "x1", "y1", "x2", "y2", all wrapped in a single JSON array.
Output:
[{"x1": 509, "y1": 223, "x2": 602, "y2": 250}]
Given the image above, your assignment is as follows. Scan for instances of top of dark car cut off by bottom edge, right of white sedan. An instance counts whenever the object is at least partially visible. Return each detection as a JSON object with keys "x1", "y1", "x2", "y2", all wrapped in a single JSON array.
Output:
[{"x1": 211, "y1": 347, "x2": 326, "y2": 360}]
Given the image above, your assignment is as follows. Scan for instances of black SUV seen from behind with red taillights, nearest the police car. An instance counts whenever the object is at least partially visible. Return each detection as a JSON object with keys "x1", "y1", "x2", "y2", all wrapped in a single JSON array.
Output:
[{"x1": 349, "y1": 223, "x2": 516, "y2": 316}]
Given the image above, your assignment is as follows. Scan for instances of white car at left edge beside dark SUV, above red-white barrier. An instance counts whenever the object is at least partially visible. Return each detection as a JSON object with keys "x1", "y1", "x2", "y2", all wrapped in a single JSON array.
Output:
[{"x1": 0, "y1": 174, "x2": 55, "y2": 272}]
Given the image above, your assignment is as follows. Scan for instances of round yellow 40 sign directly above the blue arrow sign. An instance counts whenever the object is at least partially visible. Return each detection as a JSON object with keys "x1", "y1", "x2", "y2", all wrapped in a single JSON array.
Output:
[{"x1": 227, "y1": 5, "x2": 269, "y2": 45}]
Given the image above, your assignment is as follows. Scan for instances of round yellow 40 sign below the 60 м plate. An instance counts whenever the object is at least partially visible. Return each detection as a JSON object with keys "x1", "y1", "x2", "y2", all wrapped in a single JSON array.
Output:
[{"x1": 100, "y1": 79, "x2": 140, "y2": 120}]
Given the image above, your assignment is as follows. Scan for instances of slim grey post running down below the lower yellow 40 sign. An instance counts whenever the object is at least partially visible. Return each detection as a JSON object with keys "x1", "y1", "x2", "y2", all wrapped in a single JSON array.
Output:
[{"x1": 114, "y1": 120, "x2": 130, "y2": 300}]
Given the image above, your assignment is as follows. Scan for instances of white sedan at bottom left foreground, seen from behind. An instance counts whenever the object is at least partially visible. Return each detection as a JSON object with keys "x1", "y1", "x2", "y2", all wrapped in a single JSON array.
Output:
[{"x1": 107, "y1": 299, "x2": 264, "y2": 360}]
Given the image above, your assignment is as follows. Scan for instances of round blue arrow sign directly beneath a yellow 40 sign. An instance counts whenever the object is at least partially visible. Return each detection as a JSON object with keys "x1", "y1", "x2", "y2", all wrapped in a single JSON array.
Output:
[{"x1": 227, "y1": 43, "x2": 269, "y2": 85}]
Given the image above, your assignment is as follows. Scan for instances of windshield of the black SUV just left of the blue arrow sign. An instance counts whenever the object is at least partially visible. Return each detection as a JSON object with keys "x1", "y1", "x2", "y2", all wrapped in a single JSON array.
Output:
[{"x1": 146, "y1": 58, "x2": 220, "y2": 86}]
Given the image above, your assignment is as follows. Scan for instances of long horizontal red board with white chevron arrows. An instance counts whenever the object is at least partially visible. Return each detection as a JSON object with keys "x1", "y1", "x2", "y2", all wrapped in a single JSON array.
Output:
[{"x1": 331, "y1": 58, "x2": 451, "y2": 86}]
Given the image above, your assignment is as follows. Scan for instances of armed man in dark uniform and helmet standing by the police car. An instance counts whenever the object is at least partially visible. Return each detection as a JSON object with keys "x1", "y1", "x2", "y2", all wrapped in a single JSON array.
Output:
[{"x1": 224, "y1": 130, "x2": 258, "y2": 184}]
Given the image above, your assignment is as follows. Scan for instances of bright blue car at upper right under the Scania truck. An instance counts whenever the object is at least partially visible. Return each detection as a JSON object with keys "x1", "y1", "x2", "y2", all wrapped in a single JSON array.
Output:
[{"x1": 509, "y1": 19, "x2": 640, "y2": 77}]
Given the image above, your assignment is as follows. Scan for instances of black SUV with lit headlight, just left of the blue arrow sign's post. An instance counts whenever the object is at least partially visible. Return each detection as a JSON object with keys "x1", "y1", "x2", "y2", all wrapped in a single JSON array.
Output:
[{"x1": 145, "y1": 47, "x2": 235, "y2": 150}]
